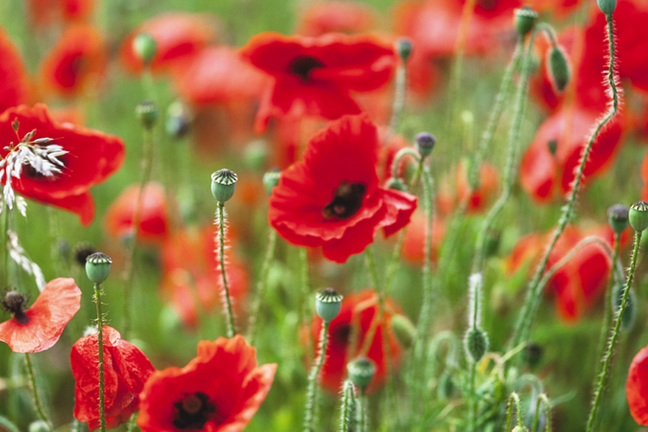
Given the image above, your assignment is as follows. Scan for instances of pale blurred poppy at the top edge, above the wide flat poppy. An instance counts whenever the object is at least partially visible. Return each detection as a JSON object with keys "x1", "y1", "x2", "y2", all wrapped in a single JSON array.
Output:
[{"x1": 297, "y1": 1, "x2": 378, "y2": 36}]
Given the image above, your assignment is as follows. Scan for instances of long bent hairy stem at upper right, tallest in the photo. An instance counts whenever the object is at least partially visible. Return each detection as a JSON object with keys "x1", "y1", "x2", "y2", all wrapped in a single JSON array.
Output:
[{"x1": 511, "y1": 15, "x2": 620, "y2": 346}]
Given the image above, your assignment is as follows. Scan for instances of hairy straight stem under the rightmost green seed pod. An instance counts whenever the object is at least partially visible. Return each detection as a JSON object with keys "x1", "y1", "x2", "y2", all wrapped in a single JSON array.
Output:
[{"x1": 585, "y1": 230, "x2": 642, "y2": 432}]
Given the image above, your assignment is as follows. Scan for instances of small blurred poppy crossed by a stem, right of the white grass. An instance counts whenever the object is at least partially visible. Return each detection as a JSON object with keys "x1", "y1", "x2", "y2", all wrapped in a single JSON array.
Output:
[{"x1": 104, "y1": 182, "x2": 169, "y2": 244}]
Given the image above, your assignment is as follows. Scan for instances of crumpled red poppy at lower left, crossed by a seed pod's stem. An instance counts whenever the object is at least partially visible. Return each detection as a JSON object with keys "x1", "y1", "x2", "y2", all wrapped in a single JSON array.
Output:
[{"x1": 70, "y1": 326, "x2": 155, "y2": 430}]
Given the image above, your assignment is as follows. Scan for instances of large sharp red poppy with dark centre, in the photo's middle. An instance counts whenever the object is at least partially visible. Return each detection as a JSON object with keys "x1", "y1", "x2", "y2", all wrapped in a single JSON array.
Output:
[{"x1": 268, "y1": 115, "x2": 416, "y2": 263}]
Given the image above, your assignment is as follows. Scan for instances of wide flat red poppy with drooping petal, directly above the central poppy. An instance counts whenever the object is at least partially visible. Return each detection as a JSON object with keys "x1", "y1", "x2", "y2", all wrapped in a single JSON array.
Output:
[{"x1": 241, "y1": 33, "x2": 396, "y2": 132}]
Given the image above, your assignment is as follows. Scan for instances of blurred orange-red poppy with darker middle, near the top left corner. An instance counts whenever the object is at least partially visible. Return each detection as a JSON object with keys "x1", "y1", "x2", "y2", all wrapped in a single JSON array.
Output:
[{"x1": 40, "y1": 24, "x2": 107, "y2": 96}]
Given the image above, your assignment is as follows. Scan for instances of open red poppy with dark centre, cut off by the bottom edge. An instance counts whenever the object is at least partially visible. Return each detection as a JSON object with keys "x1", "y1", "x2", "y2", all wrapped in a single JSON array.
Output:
[{"x1": 137, "y1": 335, "x2": 277, "y2": 432}]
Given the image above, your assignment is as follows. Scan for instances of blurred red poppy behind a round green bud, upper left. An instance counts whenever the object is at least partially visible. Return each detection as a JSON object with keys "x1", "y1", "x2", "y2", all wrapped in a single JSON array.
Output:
[{"x1": 120, "y1": 12, "x2": 218, "y2": 73}]
